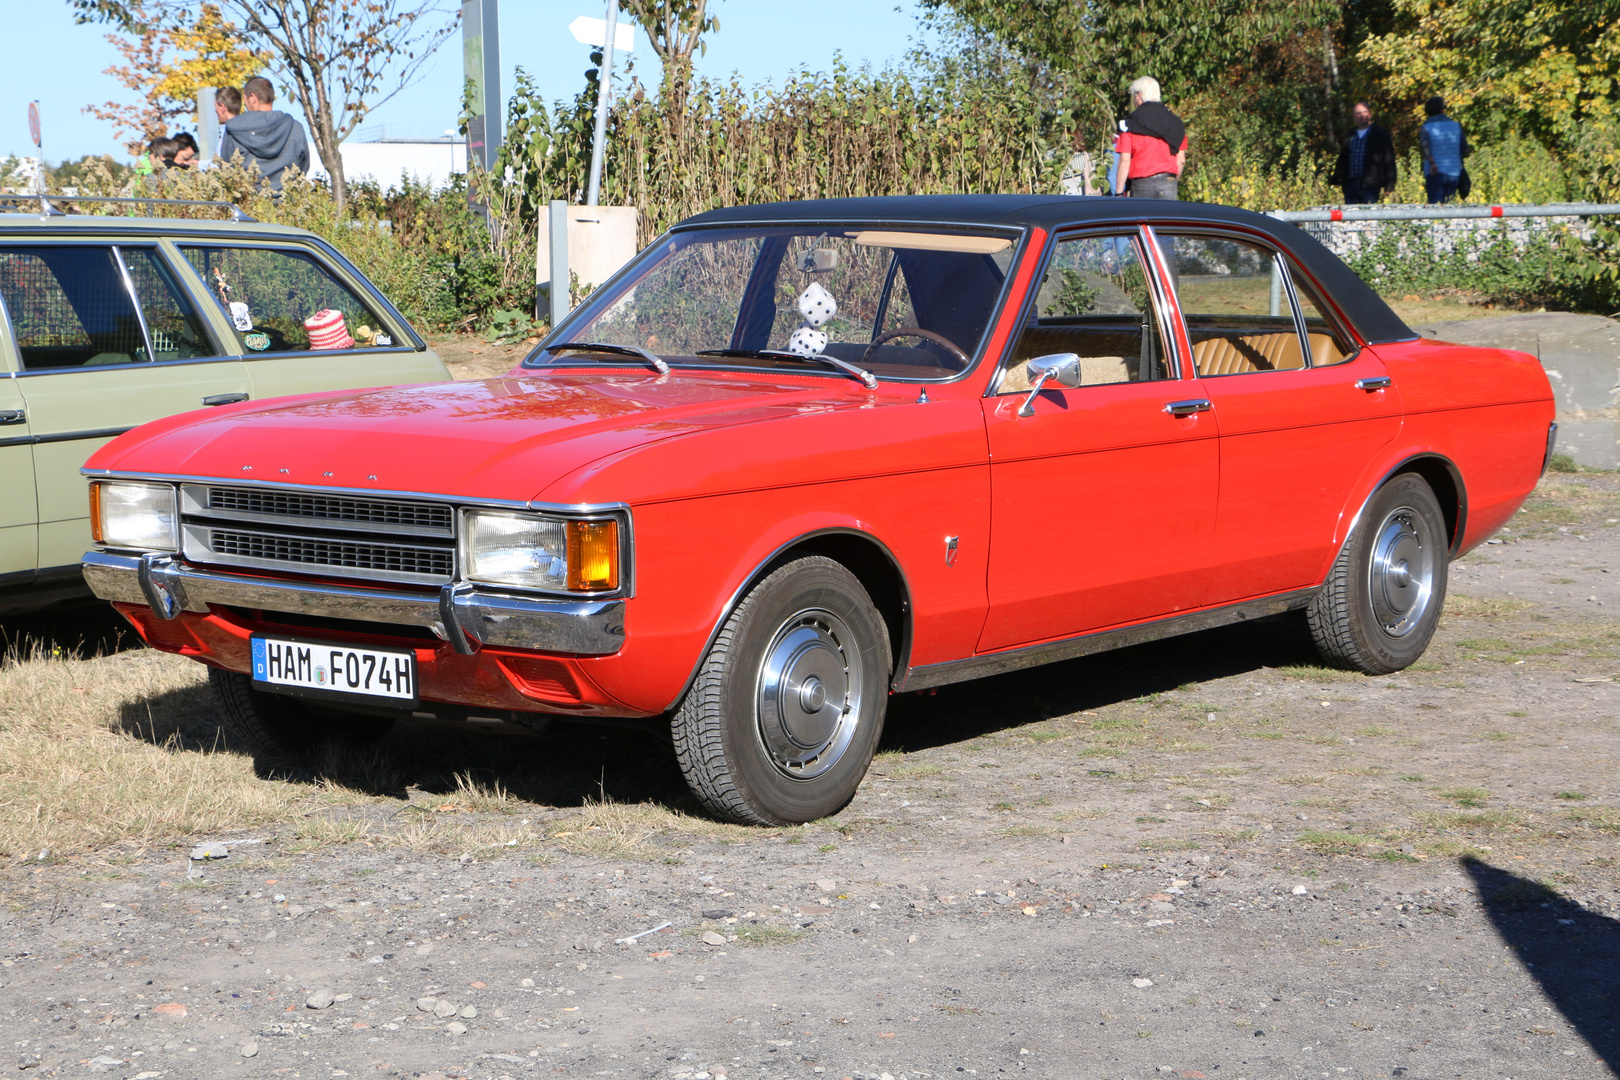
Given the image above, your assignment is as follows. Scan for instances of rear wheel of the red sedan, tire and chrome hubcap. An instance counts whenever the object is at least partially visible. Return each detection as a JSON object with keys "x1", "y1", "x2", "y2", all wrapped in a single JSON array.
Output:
[{"x1": 1306, "y1": 473, "x2": 1450, "y2": 675}]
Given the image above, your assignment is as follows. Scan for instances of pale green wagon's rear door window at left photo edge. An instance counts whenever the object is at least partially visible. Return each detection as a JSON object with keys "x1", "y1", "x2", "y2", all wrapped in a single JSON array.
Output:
[{"x1": 0, "y1": 244, "x2": 219, "y2": 371}]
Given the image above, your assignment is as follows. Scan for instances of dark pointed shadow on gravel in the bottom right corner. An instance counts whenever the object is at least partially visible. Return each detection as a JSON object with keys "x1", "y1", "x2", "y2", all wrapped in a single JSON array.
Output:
[{"x1": 1463, "y1": 858, "x2": 1620, "y2": 1075}]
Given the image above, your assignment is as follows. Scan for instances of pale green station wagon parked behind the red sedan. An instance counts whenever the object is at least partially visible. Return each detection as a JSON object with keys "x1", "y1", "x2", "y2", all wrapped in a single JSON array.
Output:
[{"x1": 0, "y1": 198, "x2": 450, "y2": 614}]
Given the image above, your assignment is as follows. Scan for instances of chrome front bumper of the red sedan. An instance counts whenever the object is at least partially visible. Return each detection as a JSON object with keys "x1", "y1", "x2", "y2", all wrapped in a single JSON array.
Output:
[{"x1": 83, "y1": 551, "x2": 624, "y2": 656}]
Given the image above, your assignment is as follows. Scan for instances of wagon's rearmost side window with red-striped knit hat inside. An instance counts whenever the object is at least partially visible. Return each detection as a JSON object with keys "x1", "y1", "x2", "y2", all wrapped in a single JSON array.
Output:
[{"x1": 181, "y1": 244, "x2": 403, "y2": 353}]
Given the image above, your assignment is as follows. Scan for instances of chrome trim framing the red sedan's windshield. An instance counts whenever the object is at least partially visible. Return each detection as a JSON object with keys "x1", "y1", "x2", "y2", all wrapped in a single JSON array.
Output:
[{"x1": 531, "y1": 219, "x2": 1035, "y2": 387}]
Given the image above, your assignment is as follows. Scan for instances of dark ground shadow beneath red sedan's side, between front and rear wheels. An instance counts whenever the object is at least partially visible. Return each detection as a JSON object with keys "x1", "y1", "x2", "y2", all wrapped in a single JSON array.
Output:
[{"x1": 883, "y1": 612, "x2": 1322, "y2": 751}]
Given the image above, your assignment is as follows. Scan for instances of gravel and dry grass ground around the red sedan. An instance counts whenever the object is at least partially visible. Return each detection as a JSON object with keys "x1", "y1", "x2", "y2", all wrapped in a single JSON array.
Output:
[{"x1": 0, "y1": 473, "x2": 1620, "y2": 1080}]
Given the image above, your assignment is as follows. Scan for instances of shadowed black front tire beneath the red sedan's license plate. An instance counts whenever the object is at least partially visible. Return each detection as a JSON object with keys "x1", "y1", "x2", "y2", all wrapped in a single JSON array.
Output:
[{"x1": 209, "y1": 667, "x2": 394, "y2": 772}]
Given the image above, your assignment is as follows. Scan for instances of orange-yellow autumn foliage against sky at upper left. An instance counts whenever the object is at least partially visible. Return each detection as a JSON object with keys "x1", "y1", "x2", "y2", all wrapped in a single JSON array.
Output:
[{"x1": 84, "y1": 0, "x2": 269, "y2": 155}]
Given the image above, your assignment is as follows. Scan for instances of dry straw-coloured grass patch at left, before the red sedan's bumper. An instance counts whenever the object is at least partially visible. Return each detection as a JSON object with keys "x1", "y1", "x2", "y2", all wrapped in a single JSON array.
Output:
[{"x1": 0, "y1": 646, "x2": 300, "y2": 860}]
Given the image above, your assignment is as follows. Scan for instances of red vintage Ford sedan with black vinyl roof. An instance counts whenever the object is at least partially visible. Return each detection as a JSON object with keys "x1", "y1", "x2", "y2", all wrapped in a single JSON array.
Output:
[{"x1": 84, "y1": 196, "x2": 1554, "y2": 824}]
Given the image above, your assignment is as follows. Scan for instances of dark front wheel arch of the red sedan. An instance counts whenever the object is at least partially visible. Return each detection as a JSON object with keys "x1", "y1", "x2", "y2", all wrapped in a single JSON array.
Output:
[{"x1": 666, "y1": 526, "x2": 912, "y2": 711}]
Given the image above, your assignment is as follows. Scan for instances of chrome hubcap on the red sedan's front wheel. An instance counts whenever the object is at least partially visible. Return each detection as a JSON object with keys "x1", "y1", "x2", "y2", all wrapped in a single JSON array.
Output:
[{"x1": 755, "y1": 607, "x2": 862, "y2": 780}]
